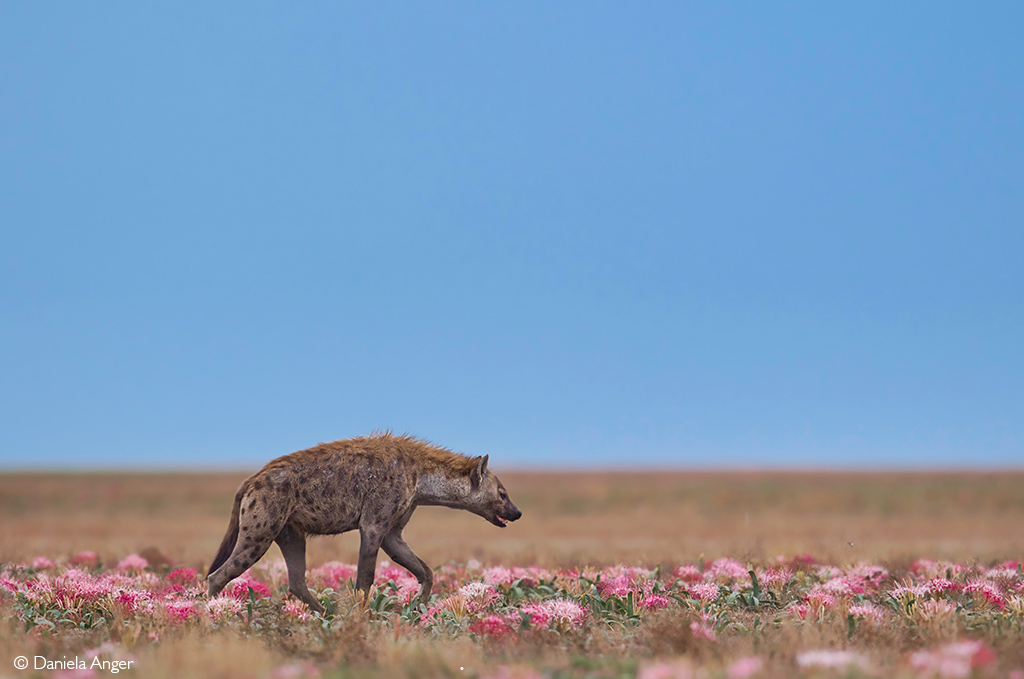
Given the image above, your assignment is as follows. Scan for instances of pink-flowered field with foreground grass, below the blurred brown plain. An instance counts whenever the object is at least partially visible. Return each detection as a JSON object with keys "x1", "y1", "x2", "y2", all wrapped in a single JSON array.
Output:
[{"x1": 0, "y1": 552, "x2": 1024, "y2": 679}]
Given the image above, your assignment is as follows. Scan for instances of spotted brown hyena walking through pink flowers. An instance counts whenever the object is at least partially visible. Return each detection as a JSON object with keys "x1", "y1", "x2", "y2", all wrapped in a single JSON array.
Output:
[{"x1": 208, "y1": 433, "x2": 522, "y2": 612}]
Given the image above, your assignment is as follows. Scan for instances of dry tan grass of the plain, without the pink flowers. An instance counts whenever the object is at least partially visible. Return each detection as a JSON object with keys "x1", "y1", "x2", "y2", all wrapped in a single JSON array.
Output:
[{"x1": 0, "y1": 470, "x2": 1024, "y2": 679}]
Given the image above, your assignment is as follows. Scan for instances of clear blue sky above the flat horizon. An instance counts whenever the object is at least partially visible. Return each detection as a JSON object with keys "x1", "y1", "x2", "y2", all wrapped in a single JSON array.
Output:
[{"x1": 0, "y1": 3, "x2": 1024, "y2": 469}]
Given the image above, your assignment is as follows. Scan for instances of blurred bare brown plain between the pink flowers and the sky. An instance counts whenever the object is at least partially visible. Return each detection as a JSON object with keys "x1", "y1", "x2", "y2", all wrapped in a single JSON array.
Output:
[{"x1": 0, "y1": 471, "x2": 1024, "y2": 572}]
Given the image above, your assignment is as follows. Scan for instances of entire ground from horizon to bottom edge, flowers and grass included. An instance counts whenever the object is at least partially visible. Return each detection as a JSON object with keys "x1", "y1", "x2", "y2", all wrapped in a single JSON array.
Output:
[{"x1": 0, "y1": 470, "x2": 1024, "y2": 679}]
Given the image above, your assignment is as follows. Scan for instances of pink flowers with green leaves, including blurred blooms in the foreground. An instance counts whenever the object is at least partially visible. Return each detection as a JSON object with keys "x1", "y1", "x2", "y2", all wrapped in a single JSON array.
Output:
[{"x1": 0, "y1": 553, "x2": 1024, "y2": 679}]
